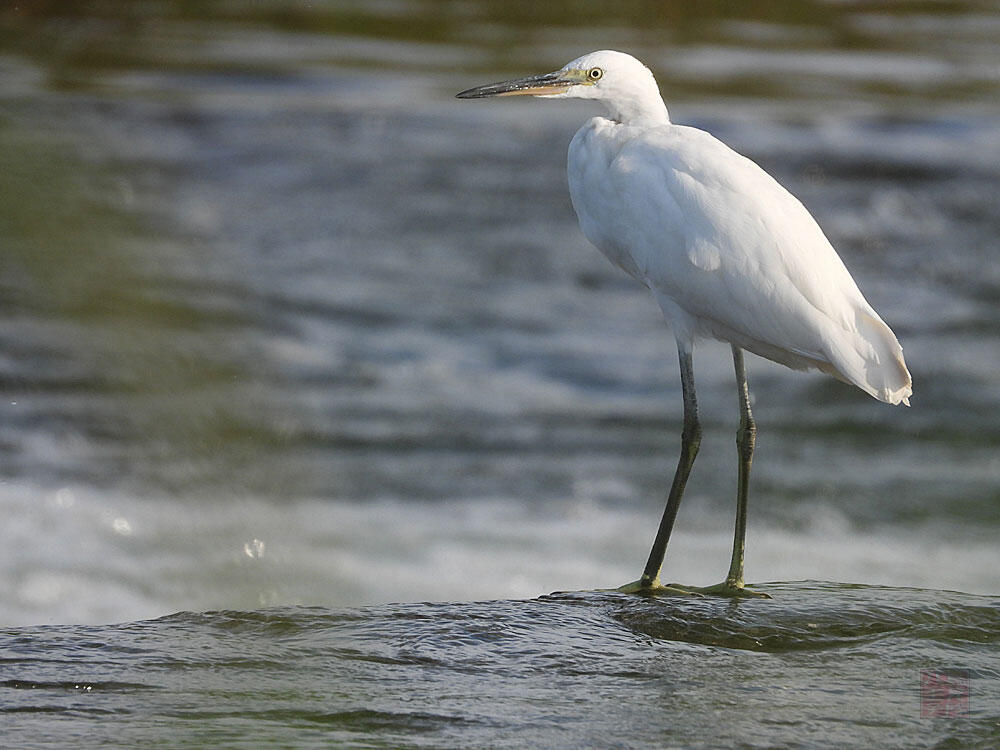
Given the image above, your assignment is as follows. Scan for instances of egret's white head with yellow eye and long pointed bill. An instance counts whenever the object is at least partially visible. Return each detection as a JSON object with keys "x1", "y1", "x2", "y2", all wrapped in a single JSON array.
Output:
[{"x1": 458, "y1": 50, "x2": 668, "y2": 123}]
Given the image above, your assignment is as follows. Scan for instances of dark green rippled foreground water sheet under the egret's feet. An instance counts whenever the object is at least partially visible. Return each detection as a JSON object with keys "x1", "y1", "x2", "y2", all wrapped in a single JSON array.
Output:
[{"x1": 0, "y1": 582, "x2": 1000, "y2": 748}]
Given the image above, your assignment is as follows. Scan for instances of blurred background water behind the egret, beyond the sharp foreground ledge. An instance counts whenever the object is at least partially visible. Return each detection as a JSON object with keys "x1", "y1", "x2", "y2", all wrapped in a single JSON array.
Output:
[{"x1": 0, "y1": 0, "x2": 1000, "y2": 624}]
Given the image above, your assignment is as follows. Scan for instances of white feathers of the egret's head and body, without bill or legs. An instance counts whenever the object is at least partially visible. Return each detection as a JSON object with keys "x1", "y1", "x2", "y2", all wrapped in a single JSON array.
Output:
[{"x1": 567, "y1": 51, "x2": 912, "y2": 404}]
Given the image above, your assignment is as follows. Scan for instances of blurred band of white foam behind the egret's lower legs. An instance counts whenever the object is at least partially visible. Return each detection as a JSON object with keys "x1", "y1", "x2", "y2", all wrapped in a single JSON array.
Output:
[{"x1": 0, "y1": 484, "x2": 997, "y2": 625}]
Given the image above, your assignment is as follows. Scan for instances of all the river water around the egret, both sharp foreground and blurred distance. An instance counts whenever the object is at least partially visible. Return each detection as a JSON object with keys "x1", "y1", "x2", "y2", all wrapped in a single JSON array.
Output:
[{"x1": 0, "y1": 0, "x2": 1000, "y2": 747}]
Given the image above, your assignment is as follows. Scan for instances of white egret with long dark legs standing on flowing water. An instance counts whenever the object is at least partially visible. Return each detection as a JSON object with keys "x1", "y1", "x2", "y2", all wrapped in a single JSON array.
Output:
[{"x1": 457, "y1": 50, "x2": 913, "y2": 598}]
